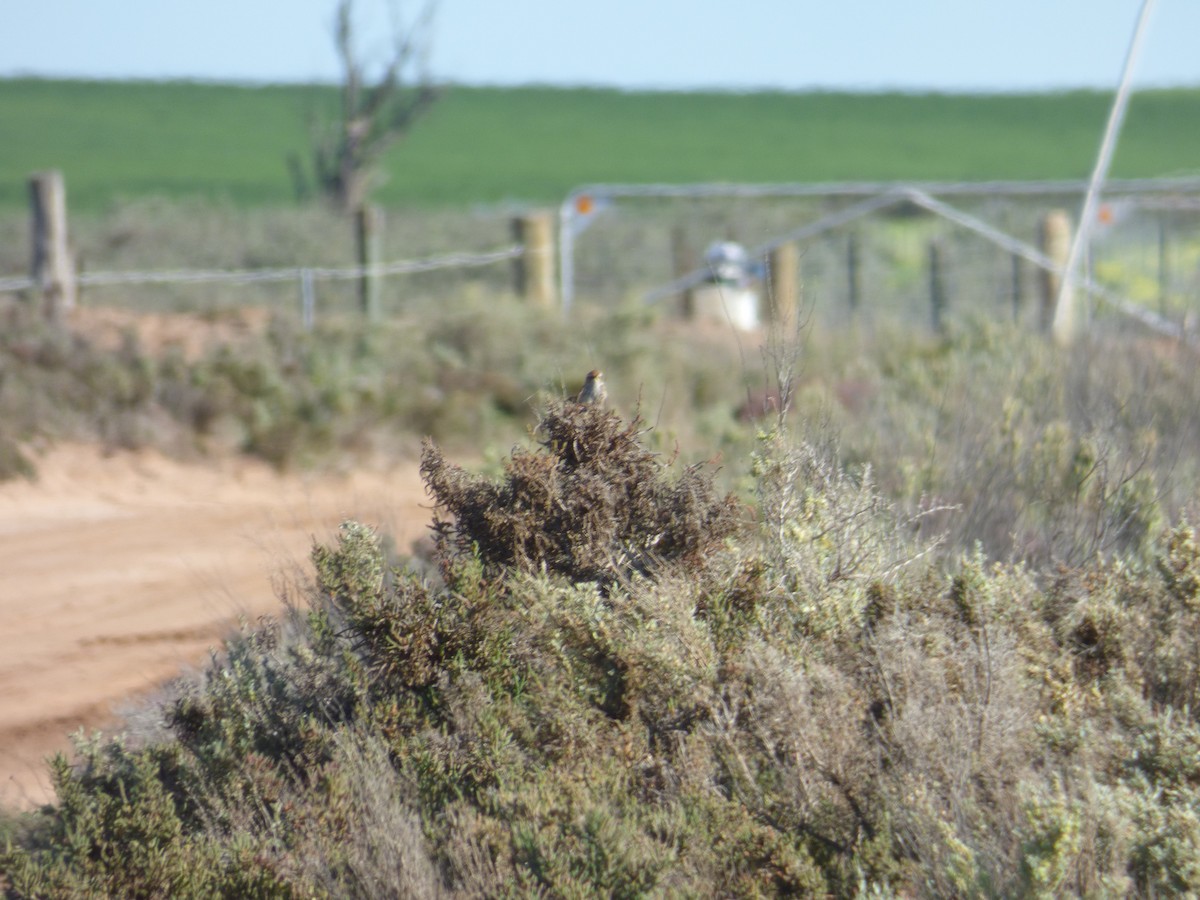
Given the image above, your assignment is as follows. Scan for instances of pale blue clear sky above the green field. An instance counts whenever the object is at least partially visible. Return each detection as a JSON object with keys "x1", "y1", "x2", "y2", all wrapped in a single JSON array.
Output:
[{"x1": 0, "y1": 0, "x2": 1200, "y2": 92}]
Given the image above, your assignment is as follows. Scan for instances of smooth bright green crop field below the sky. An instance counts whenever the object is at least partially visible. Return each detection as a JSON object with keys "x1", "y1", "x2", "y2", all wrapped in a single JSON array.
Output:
[{"x1": 7, "y1": 79, "x2": 1200, "y2": 210}]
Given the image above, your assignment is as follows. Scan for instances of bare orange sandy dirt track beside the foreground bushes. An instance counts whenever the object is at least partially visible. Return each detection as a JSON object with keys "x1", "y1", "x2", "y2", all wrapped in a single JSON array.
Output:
[{"x1": 0, "y1": 446, "x2": 430, "y2": 806}]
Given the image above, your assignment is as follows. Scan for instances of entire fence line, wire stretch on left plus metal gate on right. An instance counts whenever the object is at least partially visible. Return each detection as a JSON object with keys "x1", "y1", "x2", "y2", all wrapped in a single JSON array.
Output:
[{"x1": 7, "y1": 178, "x2": 1200, "y2": 336}]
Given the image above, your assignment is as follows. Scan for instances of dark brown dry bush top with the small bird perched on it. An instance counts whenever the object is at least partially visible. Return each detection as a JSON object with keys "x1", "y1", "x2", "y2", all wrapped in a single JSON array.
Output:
[{"x1": 421, "y1": 402, "x2": 737, "y2": 584}]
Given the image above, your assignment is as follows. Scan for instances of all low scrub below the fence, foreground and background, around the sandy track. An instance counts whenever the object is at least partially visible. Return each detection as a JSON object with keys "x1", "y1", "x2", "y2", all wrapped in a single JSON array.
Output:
[{"x1": 7, "y1": 283, "x2": 1200, "y2": 896}]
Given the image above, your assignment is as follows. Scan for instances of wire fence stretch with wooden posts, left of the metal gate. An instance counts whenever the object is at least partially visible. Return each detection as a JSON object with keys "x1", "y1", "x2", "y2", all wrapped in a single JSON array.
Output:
[{"x1": 0, "y1": 195, "x2": 544, "y2": 324}]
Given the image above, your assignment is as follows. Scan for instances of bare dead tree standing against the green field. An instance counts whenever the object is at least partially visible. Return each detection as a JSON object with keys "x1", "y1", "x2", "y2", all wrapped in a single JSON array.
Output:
[{"x1": 312, "y1": 0, "x2": 439, "y2": 212}]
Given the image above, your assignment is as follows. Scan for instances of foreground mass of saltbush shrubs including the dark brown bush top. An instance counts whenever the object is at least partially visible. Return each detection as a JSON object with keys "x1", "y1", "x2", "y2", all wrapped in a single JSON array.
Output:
[{"x1": 11, "y1": 393, "x2": 1200, "y2": 896}]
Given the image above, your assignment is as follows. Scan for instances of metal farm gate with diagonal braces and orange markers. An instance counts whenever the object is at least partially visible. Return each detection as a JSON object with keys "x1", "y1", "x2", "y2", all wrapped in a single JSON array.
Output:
[{"x1": 560, "y1": 178, "x2": 1200, "y2": 337}]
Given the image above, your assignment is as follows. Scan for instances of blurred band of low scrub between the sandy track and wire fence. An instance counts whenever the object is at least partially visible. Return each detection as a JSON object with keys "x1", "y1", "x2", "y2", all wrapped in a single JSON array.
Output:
[{"x1": 0, "y1": 290, "x2": 768, "y2": 478}]
